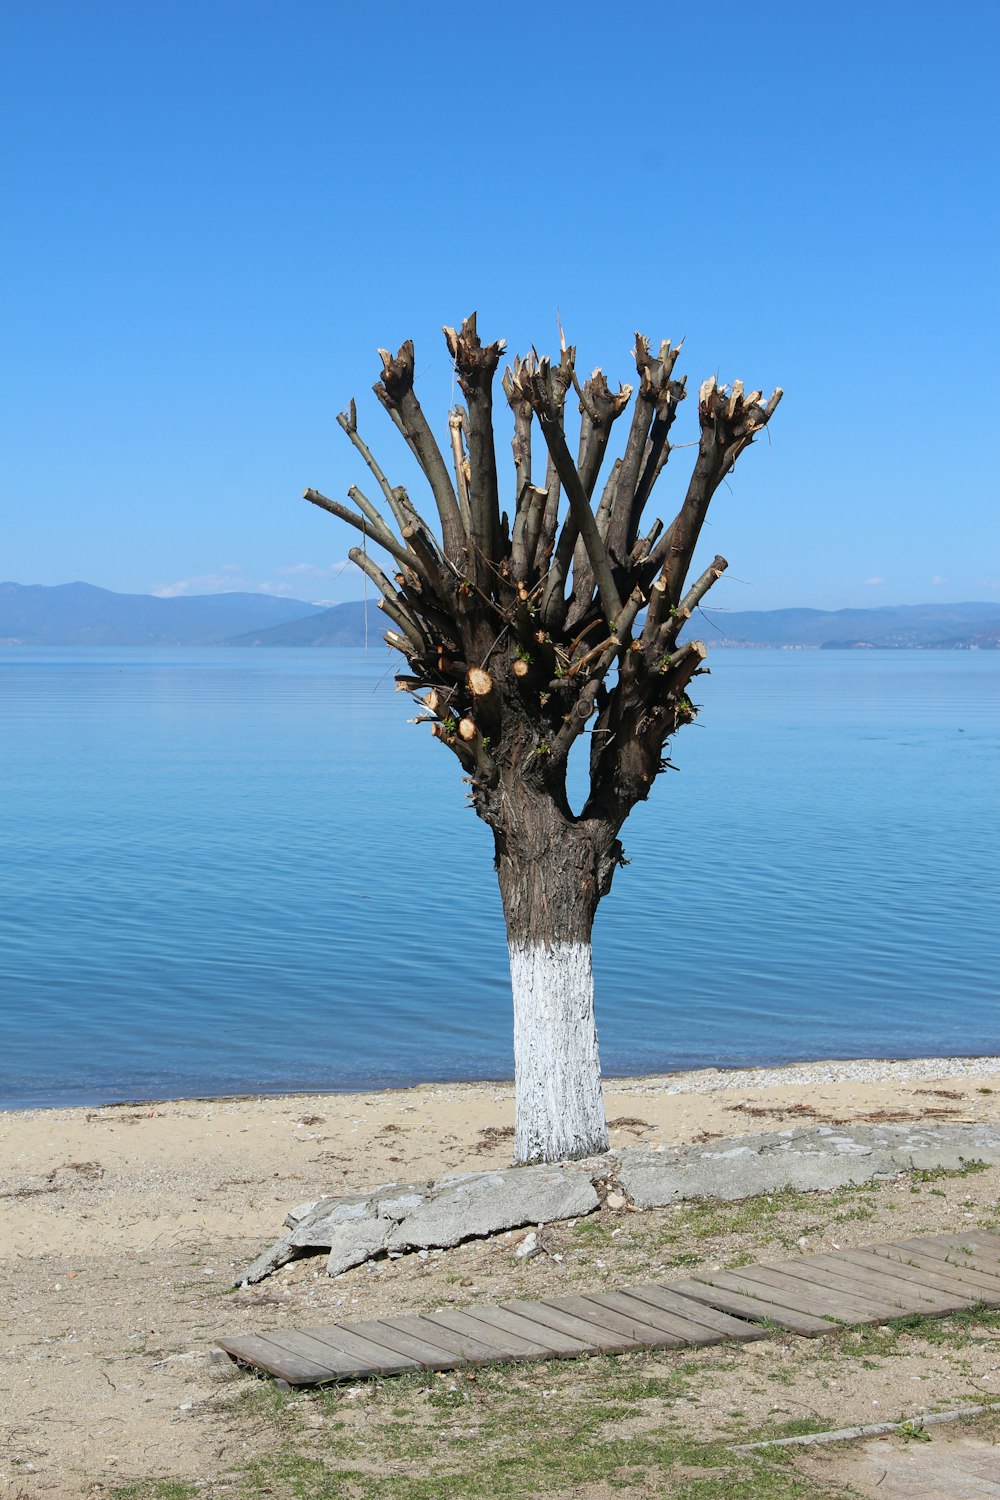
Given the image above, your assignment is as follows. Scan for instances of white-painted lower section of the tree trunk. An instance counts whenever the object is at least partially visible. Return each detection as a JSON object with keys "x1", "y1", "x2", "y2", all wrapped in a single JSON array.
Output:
[{"x1": 508, "y1": 941, "x2": 607, "y2": 1161}]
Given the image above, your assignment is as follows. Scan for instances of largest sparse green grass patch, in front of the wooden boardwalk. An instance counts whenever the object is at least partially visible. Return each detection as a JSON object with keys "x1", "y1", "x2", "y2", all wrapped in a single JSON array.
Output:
[{"x1": 228, "y1": 1350, "x2": 823, "y2": 1500}]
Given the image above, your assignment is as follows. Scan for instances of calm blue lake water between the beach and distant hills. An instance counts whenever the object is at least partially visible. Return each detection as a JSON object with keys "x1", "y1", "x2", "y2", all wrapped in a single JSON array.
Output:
[{"x1": 0, "y1": 647, "x2": 1000, "y2": 1107}]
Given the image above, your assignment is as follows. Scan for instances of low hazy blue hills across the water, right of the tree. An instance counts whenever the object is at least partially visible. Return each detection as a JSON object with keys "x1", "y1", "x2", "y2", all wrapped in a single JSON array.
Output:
[{"x1": 687, "y1": 603, "x2": 1000, "y2": 651}]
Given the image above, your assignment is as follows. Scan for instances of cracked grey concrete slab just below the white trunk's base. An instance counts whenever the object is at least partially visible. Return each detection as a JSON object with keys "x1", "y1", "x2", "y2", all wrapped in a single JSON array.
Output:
[{"x1": 388, "y1": 1167, "x2": 598, "y2": 1250}]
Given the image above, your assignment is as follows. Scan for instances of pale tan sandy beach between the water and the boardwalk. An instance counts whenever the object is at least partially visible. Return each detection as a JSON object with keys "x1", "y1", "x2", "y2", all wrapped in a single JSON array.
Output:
[{"x1": 0, "y1": 1058, "x2": 1000, "y2": 1497}]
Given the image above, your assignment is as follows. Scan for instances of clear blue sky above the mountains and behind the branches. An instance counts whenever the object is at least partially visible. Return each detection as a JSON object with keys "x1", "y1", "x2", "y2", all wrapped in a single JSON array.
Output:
[{"x1": 0, "y1": 0, "x2": 1000, "y2": 609}]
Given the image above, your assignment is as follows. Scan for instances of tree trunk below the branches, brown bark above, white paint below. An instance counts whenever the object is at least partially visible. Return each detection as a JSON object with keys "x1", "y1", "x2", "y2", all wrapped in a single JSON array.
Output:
[{"x1": 496, "y1": 783, "x2": 609, "y2": 1163}]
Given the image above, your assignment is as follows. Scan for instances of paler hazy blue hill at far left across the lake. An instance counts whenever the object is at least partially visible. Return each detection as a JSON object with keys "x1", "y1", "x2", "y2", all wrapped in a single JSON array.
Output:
[{"x1": 0, "y1": 584, "x2": 322, "y2": 647}]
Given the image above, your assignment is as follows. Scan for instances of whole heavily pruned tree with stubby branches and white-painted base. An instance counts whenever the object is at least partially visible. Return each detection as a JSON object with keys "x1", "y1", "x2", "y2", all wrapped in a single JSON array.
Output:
[{"x1": 306, "y1": 314, "x2": 781, "y2": 1161}]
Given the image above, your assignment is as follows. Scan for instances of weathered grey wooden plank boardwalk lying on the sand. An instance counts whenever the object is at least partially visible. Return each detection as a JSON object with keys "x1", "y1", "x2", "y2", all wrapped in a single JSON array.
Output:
[{"x1": 217, "y1": 1230, "x2": 1000, "y2": 1386}]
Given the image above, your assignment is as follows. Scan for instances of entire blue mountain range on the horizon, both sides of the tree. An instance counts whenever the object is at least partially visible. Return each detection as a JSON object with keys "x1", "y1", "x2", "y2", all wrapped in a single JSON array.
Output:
[{"x1": 0, "y1": 584, "x2": 1000, "y2": 651}]
